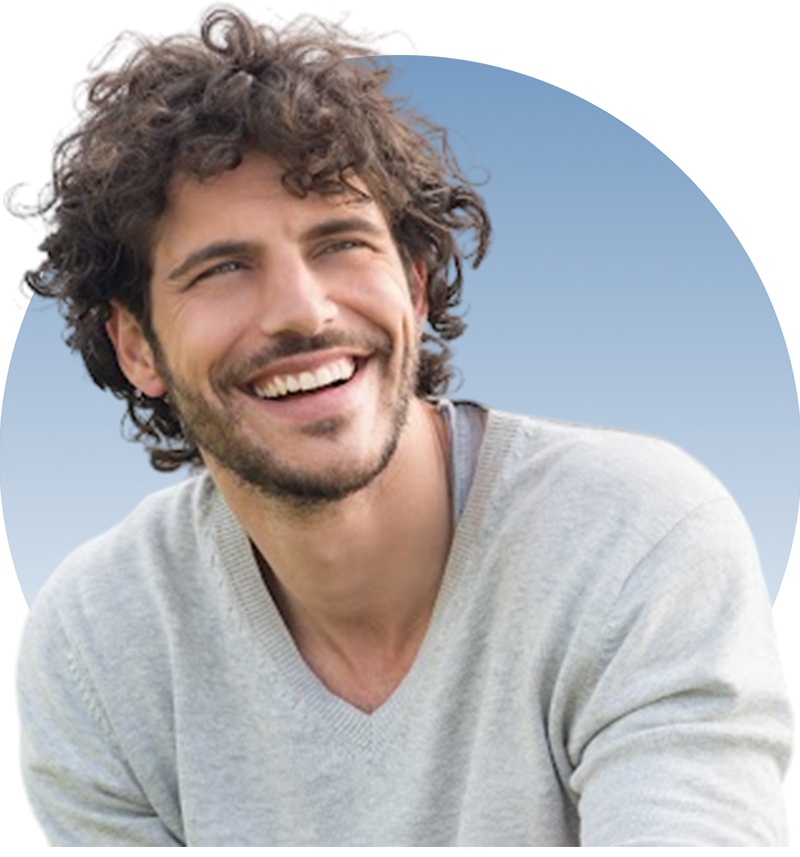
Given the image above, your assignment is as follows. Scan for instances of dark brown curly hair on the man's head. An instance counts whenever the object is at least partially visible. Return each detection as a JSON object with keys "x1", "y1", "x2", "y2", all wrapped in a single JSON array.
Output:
[{"x1": 26, "y1": 11, "x2": 491, "y2": 473}]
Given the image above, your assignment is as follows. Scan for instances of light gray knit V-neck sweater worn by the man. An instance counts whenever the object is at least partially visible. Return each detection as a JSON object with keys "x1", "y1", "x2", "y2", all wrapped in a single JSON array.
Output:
[{"x1": 13, "y1": 397, "x2": 792, "y2": 855}]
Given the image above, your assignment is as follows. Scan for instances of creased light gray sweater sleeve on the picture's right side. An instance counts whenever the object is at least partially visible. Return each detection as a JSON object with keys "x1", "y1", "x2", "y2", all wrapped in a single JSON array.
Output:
[{"x1": 568, "y1": 496, "x2": 792, "y2": 850}]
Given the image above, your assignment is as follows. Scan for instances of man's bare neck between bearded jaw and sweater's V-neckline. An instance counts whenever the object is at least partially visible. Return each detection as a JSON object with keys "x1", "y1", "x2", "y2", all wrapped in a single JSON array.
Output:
[{"x1": 239, "y1": 402, "x2": 453, "y2": 652}]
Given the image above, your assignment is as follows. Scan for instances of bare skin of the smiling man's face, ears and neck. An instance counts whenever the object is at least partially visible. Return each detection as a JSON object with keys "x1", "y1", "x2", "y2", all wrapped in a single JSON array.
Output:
[{"x1": 107, "y1": 154, "x2": 452, "y2": 684}]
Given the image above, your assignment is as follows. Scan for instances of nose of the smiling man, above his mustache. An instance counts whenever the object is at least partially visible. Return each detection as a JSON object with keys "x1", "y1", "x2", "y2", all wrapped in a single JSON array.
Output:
[{"x1": 260, "y1": 254, "x2": 338, "y2": 337}]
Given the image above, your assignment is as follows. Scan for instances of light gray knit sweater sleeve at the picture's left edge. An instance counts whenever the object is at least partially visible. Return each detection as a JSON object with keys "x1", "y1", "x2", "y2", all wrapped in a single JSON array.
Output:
[{"x1": 13, "y1": 588, "x2": 185, "y2": 854}]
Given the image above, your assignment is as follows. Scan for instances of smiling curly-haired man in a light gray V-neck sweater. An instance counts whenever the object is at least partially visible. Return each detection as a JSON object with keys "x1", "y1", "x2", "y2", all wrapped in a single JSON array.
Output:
[{"x1": 14, "y1": 5, "x2": 791, "y2": 853}]
